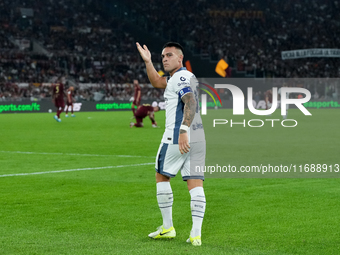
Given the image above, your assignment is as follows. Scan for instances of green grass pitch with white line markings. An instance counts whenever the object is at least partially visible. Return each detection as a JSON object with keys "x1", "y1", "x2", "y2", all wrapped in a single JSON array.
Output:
[{"x1": 0, "y1": 109, "x2": 340, "y2": 255}]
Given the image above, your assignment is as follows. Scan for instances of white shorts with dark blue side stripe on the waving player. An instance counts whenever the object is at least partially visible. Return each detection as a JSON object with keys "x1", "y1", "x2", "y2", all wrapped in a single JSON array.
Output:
[{"x1": 155, "y1": 141, "x2": 205, "y2": 181}]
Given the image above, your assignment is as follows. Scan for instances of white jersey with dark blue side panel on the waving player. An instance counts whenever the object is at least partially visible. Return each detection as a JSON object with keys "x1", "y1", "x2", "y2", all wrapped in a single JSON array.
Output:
[{"x1": 162, "y1": 67, "x2": 205, "y2": 144}]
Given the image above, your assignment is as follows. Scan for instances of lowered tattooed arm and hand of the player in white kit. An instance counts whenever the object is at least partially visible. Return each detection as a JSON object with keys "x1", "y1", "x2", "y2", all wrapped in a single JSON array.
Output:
[{"x1": 178, "y1": 92, "x2": 196, "y2": 154}]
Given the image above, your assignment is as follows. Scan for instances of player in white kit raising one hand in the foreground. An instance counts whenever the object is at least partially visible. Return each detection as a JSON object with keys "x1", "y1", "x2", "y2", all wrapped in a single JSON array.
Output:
[{"x1": 136, "y1": 42, "x2": 206, "y2": 246}]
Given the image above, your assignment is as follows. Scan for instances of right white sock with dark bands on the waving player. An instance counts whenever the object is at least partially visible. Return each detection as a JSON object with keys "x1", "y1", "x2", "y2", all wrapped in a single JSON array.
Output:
[{"x1": 189, "y1": 187, "x2": 206, "y2": 237}]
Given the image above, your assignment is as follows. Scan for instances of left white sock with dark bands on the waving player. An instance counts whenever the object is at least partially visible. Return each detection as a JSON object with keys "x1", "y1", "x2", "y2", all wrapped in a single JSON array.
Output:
[{"x1": 157, "y1": 182, "x2": 174, "y2": 229}]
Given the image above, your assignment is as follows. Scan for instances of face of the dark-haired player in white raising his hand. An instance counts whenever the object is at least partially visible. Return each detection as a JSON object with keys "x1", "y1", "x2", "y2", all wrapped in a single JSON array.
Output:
[{"x1": 162, "y1": 47, "x2": 183, "y2": 75}]
